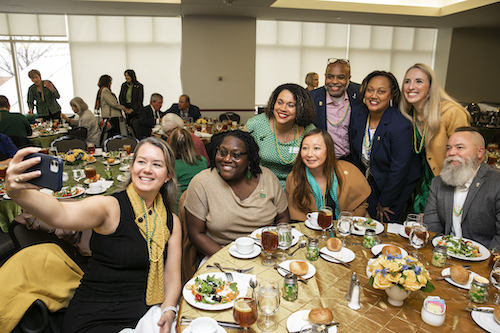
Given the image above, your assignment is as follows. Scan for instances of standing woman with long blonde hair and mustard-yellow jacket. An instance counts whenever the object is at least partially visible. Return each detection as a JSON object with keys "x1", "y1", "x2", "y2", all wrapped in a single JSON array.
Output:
[{"x1": 400, "y1": 63, "x2": 470, "y2": 213}]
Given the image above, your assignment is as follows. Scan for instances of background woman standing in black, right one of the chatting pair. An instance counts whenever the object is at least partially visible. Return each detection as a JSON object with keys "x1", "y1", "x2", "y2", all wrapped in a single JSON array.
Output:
[{"x1": 119, "y1": 69, "x2": 144, "y2": 124}]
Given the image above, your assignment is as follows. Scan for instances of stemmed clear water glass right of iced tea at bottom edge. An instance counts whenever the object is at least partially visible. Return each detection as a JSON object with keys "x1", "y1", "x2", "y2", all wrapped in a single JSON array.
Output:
[{"x1": 257, "y1": 281, "x2": 280, "y2": 332}]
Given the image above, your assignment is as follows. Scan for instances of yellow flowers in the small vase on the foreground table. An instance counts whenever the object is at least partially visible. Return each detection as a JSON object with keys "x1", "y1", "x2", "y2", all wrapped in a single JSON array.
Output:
[{"x1": 368, "y1": 254, "x2": 434, "y2": 292}]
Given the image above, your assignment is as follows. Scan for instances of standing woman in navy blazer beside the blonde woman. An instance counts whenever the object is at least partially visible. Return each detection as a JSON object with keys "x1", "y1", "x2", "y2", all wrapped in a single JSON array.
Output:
[{"x1": 349, "y1": 71, "x2": 421, "y2": 221}]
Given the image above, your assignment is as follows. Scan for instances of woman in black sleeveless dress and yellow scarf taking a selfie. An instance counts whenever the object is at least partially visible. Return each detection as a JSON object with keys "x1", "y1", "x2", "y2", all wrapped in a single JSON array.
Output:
[{"x1": 6, "y1": 138, "x2": 181, "y2": 333}]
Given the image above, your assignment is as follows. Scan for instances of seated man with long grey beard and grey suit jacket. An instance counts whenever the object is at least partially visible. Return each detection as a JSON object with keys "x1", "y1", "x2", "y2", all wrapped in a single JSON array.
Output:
[{"x1": 424, "y1": 127, "x2": 500, "y2": 249}]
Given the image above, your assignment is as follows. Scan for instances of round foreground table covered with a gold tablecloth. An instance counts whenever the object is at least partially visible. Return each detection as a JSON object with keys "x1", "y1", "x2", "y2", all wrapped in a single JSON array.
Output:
[{"x1": 176, "y1": 222, "x2": 500, "y2": 333}]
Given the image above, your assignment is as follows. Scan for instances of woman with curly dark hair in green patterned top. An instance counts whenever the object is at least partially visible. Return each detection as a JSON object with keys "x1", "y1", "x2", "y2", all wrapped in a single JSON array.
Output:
[{"x1": 246, "y1": 83, "x2": 315, "y2": 189}]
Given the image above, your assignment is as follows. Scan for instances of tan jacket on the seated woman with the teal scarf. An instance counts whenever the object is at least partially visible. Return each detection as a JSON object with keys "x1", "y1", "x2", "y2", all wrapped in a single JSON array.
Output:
[{"x1": 286, "y1": 161, "x2": 372, "y2": 221}]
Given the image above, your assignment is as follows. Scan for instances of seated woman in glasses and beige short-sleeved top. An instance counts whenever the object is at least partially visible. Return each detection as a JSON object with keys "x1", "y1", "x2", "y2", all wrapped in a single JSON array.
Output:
[{"x1": 185, "y1": 130, "x2": 290, "y2": 256}]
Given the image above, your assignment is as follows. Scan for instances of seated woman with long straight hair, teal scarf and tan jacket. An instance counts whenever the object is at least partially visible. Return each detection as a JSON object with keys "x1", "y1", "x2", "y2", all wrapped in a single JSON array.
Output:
[{"x1": 286, "y1": 128, "x2": 371, "y2": 221}]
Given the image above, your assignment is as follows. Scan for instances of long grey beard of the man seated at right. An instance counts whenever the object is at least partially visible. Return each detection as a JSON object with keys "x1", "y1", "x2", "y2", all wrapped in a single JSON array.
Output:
[{"x1": 440, "y1": 156, "x2": 478, "y2": 187}]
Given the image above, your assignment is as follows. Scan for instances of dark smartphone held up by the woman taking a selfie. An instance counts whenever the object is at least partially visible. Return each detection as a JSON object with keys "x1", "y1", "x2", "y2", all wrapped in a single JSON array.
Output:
[{"x1": 24, "y1": 153, "x2": 64, "y2": 191}]
